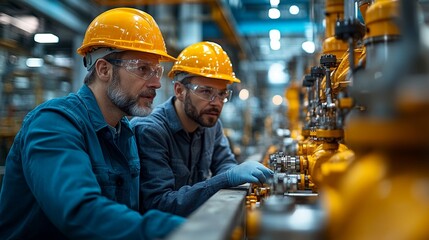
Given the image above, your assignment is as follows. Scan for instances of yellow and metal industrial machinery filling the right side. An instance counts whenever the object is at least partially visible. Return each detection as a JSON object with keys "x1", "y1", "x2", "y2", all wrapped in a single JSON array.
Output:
[{"x1": 166, "y1": 0, "x2": 429, "y2": 240}]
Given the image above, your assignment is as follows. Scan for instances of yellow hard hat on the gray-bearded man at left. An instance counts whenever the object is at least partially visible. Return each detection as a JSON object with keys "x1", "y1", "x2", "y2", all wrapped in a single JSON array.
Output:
[{"x1": 77, "y1": 8, "x2": 176, "y2": 66}]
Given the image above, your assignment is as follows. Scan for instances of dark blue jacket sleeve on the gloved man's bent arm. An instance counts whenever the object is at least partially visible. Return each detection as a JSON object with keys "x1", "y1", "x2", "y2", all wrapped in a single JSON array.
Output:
[{"x1": 135, "y1": 124, "x2": 229, "y2": 216}]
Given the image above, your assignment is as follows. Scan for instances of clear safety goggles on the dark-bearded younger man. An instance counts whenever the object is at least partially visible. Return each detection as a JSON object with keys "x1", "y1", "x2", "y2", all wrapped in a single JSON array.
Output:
[{"x1": 185, "y1": 83, "x2": 232, "y2": 103}]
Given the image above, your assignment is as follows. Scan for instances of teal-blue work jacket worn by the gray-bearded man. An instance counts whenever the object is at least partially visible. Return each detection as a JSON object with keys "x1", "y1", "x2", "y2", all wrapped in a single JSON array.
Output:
[{"x1": 0, "y1": 85, "x2": 183, "y2": 239}]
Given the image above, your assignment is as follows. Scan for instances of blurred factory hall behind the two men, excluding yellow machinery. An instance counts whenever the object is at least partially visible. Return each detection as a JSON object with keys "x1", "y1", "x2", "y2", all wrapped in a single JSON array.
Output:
[{"x1": 0, "y1": 0, "x2": 332, "y2": 165}]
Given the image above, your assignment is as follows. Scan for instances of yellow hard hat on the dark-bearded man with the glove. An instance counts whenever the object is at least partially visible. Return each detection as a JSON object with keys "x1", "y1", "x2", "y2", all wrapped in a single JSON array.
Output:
[{"x1": 168, "y1": 42, "x2": 240, "y2": 83}]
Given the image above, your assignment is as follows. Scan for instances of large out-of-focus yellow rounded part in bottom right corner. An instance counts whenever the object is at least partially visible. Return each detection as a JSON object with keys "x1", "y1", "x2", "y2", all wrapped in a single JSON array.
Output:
[{"x1": 322, "y1": 152, "x2": 429, "y2": 240}]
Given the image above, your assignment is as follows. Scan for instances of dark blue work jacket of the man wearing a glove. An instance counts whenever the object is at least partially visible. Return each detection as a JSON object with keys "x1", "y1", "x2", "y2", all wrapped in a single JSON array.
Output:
[{"x1": 130, "y1": 97, "x2": 237, "y2": 216}]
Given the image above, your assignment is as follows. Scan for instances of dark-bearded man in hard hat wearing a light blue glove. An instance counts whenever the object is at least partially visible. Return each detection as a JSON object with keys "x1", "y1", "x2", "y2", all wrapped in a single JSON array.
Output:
[{"x1": 131, "y1": 42, "x2": 273, "y2": 216}]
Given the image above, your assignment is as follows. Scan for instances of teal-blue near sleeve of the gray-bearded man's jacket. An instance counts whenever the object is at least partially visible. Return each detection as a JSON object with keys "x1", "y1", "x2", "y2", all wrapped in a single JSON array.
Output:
[{"x1": 22, "y1": 109, "x2": 183, "y2": 239}]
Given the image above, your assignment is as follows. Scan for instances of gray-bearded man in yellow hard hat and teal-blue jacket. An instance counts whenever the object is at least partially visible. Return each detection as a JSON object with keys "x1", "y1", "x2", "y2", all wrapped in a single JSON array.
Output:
[{"x1": 0, "y1": 8, "x2": 184, "y2": 240}]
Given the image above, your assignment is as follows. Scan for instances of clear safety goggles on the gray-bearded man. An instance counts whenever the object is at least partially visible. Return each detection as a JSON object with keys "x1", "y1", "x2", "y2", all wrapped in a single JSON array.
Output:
[{"x1": 106, "y1": 59, "x2": 164, "y2": 81}]
